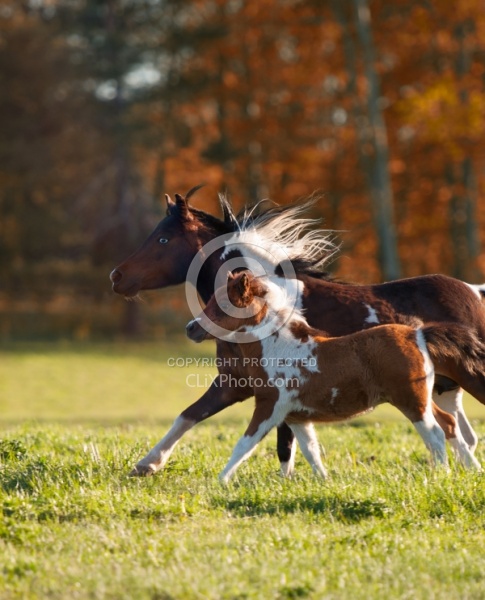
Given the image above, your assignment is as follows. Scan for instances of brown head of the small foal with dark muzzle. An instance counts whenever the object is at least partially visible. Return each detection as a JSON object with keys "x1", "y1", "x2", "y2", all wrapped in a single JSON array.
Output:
[{"x1": 186, "y1": 271, "x2": 268, "y2": 342}]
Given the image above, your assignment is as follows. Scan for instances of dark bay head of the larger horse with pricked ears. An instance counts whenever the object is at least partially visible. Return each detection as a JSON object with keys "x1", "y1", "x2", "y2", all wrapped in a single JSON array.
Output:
[{"x1": 110, "y1": 187, "x2": 232, "y2": 297}]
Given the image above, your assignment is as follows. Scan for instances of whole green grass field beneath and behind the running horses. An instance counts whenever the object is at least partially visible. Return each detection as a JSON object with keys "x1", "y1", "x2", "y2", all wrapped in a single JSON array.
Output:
[{"x1": 0, "y1": 342, "x2": 485, "y2": 600}]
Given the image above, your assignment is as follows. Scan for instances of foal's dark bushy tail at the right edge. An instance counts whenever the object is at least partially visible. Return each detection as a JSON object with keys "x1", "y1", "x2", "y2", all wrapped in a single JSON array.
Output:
[{"x1": 420, "y1": 323, "x2": 485, "y2": 404}]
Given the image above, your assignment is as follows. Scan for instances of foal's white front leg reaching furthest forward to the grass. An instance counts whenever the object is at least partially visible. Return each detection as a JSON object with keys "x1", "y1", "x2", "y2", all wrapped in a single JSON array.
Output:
[{"x1": 219, "y1": 402, "x2": 281, "y2": 483}]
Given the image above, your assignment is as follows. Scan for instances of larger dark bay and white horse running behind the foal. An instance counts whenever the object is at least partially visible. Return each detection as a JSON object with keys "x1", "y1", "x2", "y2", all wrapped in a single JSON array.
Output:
[{"x1": 110, "y1": 188, "x2": 485, "y2": 475}]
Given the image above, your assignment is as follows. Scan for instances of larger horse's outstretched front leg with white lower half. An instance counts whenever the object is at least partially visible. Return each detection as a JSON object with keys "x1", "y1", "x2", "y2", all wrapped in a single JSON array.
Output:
[{"x1": 130, "y1": 377, "x2": 253, "y2": 477}]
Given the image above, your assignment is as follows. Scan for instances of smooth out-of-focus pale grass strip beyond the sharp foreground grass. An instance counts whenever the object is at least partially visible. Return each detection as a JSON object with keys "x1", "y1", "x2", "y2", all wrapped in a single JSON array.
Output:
[{"x1": 0, "y1": 339, "x2": 485, "y2": 423}]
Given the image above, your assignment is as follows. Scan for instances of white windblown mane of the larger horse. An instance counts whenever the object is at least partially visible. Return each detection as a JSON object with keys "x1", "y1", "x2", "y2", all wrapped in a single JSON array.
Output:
[{"x1": 221, "y1": 197, "x2": 340, "y2": 271}]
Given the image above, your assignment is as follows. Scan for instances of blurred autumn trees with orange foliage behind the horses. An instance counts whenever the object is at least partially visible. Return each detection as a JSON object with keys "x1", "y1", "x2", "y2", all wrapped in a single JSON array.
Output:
[{"x1": 0, "y1": 0, "x2": 485, "y2": 337}]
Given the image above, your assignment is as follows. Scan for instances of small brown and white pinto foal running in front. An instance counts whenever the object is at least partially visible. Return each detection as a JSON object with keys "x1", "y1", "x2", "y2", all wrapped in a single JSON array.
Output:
[{"x1": 187, "y1": 272, "x2": 485, "y2": 482}]
